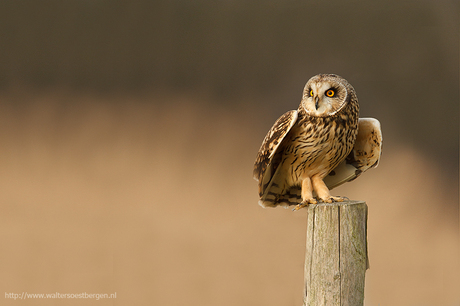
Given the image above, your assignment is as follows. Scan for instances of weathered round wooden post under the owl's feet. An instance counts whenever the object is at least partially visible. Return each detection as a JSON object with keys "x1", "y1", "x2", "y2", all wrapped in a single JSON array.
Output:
[{"x1": 304, "y1": 201, "x2": 369, "y2": 306}]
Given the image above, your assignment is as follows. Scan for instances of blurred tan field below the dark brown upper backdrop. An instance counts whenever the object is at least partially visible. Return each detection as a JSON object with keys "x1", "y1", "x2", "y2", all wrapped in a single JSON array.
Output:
[{"x1": 0, "y1": 91, "x2": 460, "y2": 306}]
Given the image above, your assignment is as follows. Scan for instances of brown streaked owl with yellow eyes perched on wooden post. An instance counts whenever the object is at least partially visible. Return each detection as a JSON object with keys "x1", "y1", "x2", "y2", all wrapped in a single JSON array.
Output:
[{"x1": 253, "y1": 74, "x2": 382, "y2": 209}]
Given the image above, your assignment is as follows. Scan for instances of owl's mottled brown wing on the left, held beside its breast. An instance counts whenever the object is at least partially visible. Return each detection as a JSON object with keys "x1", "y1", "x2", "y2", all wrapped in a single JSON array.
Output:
[{"x1": 253, "y1": 110, "x2": 298, "y2": 194}]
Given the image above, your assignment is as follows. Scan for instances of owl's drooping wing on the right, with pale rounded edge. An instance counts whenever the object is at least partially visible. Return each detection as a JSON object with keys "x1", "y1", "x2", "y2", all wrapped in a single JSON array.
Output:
[{"x1": 324, "y1": 118, "x2": 383, "y2": 189}]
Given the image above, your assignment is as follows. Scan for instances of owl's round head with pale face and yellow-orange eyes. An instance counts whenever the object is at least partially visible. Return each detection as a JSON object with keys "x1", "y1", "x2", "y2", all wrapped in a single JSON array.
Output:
[{"x1": 300, "y1": 74, "x2": 356, "y2": 117}]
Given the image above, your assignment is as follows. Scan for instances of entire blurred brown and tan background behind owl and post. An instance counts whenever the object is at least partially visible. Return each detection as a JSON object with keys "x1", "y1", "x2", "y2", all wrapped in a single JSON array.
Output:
[{"x1": 0, "y1": 0, "x2": 460, "y2": 306}]
